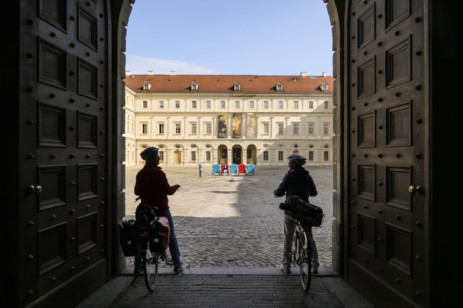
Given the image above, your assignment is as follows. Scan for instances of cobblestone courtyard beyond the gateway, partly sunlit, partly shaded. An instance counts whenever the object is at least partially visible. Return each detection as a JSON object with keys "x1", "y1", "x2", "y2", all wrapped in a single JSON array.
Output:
[{"x1": 126, "y1": 166, "x2": 333, "y2": 268}]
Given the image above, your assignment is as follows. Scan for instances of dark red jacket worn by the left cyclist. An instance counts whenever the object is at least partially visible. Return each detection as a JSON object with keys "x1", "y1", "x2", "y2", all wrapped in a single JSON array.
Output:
[{"x1": 135, "y1": 164, "x2": 177, "y2": 211}]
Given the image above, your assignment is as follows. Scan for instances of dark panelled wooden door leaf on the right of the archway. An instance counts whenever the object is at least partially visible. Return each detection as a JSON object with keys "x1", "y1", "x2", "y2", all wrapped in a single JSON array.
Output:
[{"x1": 346, "y1": 0, "x2": 427, "y2": 307}]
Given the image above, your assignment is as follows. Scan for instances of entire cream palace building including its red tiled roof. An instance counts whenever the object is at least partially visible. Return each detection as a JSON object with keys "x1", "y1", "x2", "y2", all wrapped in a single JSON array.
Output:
[{"x1": 124, "y1": 71, "x2": 334, "y2": 166}]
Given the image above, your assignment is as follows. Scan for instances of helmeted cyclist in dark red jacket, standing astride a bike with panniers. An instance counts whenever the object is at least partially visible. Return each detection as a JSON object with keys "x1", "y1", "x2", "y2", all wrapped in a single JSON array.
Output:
[{"x1": 135, "y1": 147, "x2": 183, "y2": 273}]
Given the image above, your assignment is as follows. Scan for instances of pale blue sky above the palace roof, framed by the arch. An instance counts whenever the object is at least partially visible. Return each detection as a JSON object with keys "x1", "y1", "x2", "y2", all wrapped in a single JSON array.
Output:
[{"x1": 126, "y1": 0, "x2": 333, "y2": 76}]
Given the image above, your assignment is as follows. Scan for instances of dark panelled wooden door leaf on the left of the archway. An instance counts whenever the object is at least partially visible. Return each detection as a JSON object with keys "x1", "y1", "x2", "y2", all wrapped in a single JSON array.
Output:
[{"x1": 17, "y1": 0, "x2": 110, "y2": 307}]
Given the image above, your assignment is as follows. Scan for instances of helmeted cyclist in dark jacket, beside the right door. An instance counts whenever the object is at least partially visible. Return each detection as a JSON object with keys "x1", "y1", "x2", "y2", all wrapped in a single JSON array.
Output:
[{"x1": 273, "y1": 154, "x2": 319, "y2": 274}]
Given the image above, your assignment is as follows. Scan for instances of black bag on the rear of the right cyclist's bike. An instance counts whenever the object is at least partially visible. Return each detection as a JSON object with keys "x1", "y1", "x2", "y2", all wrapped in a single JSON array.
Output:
[{"x1": 280, "y1": 195, "x2": 323, "y2": 227}]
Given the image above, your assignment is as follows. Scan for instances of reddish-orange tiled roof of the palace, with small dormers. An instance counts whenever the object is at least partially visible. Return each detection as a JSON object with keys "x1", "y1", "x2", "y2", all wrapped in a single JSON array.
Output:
[{"x1": 124, "y1": 75, "x2": 334, "y2": 94}]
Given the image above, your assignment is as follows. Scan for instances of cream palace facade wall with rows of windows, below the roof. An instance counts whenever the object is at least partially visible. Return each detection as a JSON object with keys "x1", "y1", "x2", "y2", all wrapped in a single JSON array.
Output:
[{"x1": 124, "y1": 88, "x2": 333, "y2": 166}]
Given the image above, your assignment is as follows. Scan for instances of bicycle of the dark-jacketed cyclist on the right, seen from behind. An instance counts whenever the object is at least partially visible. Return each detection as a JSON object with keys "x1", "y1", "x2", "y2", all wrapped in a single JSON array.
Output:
[{"x1": 291, "y1": 217, "x2": 312, "y2": 293}]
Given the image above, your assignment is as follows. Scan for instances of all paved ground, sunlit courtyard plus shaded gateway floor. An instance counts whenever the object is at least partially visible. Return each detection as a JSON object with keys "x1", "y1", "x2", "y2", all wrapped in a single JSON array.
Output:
[{"x1": 77, "y1": 167, "x2": 373, "y2": 308}]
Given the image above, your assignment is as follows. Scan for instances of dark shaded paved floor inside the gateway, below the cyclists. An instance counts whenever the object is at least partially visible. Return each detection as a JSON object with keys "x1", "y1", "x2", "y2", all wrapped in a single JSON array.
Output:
[{"x1": 111, "y1": 275, "x2": 344, "y2": 308}]
